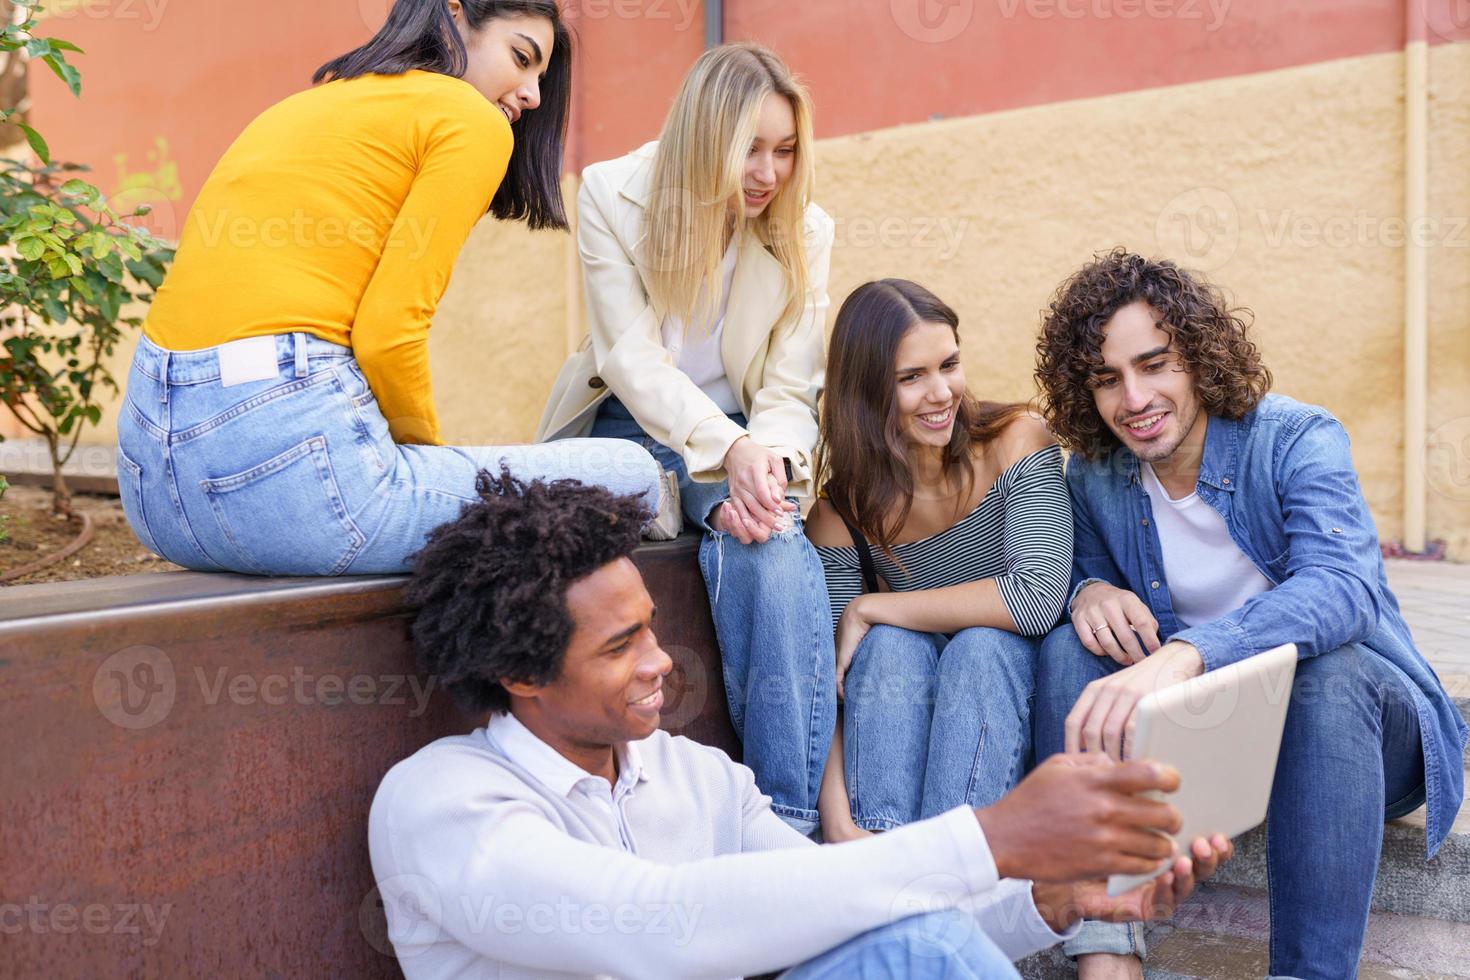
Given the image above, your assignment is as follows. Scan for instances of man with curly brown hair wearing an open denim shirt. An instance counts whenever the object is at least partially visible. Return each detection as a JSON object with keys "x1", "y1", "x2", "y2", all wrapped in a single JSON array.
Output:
[{"x1": 1036, "y1": 250, "x2": 1466, "y2": 980}]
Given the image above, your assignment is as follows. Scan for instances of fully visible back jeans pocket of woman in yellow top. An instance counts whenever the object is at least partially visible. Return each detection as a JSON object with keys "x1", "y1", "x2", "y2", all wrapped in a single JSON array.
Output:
[{"x1": 200, "y1": 435, "x2": 366, "y2": 574}]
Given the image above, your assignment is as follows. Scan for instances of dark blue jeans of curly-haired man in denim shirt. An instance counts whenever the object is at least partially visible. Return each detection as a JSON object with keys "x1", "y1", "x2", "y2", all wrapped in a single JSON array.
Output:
[{"x1": 1036, "y1": 624, "x2": 1424, "y2": 980}]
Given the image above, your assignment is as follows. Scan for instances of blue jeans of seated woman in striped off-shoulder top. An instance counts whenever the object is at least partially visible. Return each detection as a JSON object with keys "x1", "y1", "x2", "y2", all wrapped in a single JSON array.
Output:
[{"x1": 842, "y1": 624, "x2": 1038, "y2": 830}]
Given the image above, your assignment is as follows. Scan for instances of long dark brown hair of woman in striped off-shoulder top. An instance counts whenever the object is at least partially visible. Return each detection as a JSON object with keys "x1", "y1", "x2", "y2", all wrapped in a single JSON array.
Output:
[{"x1": 817, "y1": 279, "x2": 1026, "y2": 557}]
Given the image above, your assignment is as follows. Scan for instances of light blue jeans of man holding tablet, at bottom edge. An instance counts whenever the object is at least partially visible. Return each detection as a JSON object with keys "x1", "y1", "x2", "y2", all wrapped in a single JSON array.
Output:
[{"x1": 779, "y1": 909, "x2": 1020, "y2": 980}]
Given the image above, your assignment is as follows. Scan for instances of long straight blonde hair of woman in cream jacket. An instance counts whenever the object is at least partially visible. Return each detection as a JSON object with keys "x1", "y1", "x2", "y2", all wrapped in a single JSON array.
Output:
[{"x1": 644, "y1": 43, "x2": 814, "y2": 326}]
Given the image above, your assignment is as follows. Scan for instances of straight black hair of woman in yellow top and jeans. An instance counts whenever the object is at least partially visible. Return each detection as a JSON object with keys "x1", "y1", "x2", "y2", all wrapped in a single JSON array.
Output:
[{"x1": 312, "y1": 0, "x2": 572, "y2": 231}]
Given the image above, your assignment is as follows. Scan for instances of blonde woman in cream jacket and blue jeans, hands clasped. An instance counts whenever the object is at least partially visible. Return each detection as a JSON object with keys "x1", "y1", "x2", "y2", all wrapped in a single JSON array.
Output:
[{"x1": 541, "y1": 44, "x2": 835, "y2": 832}]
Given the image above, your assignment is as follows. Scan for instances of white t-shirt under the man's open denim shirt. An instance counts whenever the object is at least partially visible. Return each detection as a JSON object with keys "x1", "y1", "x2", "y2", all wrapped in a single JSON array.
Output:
[{"x1": 1141, "y1": 463, "x2": 1272, "y2": 626}]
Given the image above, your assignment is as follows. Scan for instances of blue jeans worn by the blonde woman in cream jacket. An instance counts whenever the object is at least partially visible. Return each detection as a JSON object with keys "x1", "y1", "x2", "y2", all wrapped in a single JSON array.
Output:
[{"x1": 592, "y1": 398, "x2": 836, "y2": 835}]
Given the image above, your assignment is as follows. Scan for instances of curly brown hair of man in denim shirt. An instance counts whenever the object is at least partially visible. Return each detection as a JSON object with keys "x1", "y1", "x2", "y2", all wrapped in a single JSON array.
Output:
[{"x1": 1036, "y1": 248, "x2": 1272, "y2": 458}]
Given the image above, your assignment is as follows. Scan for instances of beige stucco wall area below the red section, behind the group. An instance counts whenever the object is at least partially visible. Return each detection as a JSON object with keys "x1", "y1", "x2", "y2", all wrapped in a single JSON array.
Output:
[{"x1": 34, "y1": 44, "x2": 1470, "y2": 558}]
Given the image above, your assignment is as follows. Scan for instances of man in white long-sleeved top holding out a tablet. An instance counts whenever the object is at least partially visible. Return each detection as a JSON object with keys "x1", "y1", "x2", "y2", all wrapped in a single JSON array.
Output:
[{"x1": 369, "y1": 472, "x2": 1230, "y2": 980}]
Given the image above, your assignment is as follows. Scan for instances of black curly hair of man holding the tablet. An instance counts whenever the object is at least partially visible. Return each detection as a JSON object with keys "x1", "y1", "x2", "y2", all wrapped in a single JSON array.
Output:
[{"x1": 404, "y1": 466, "x2": 650, "y2": 713}]
